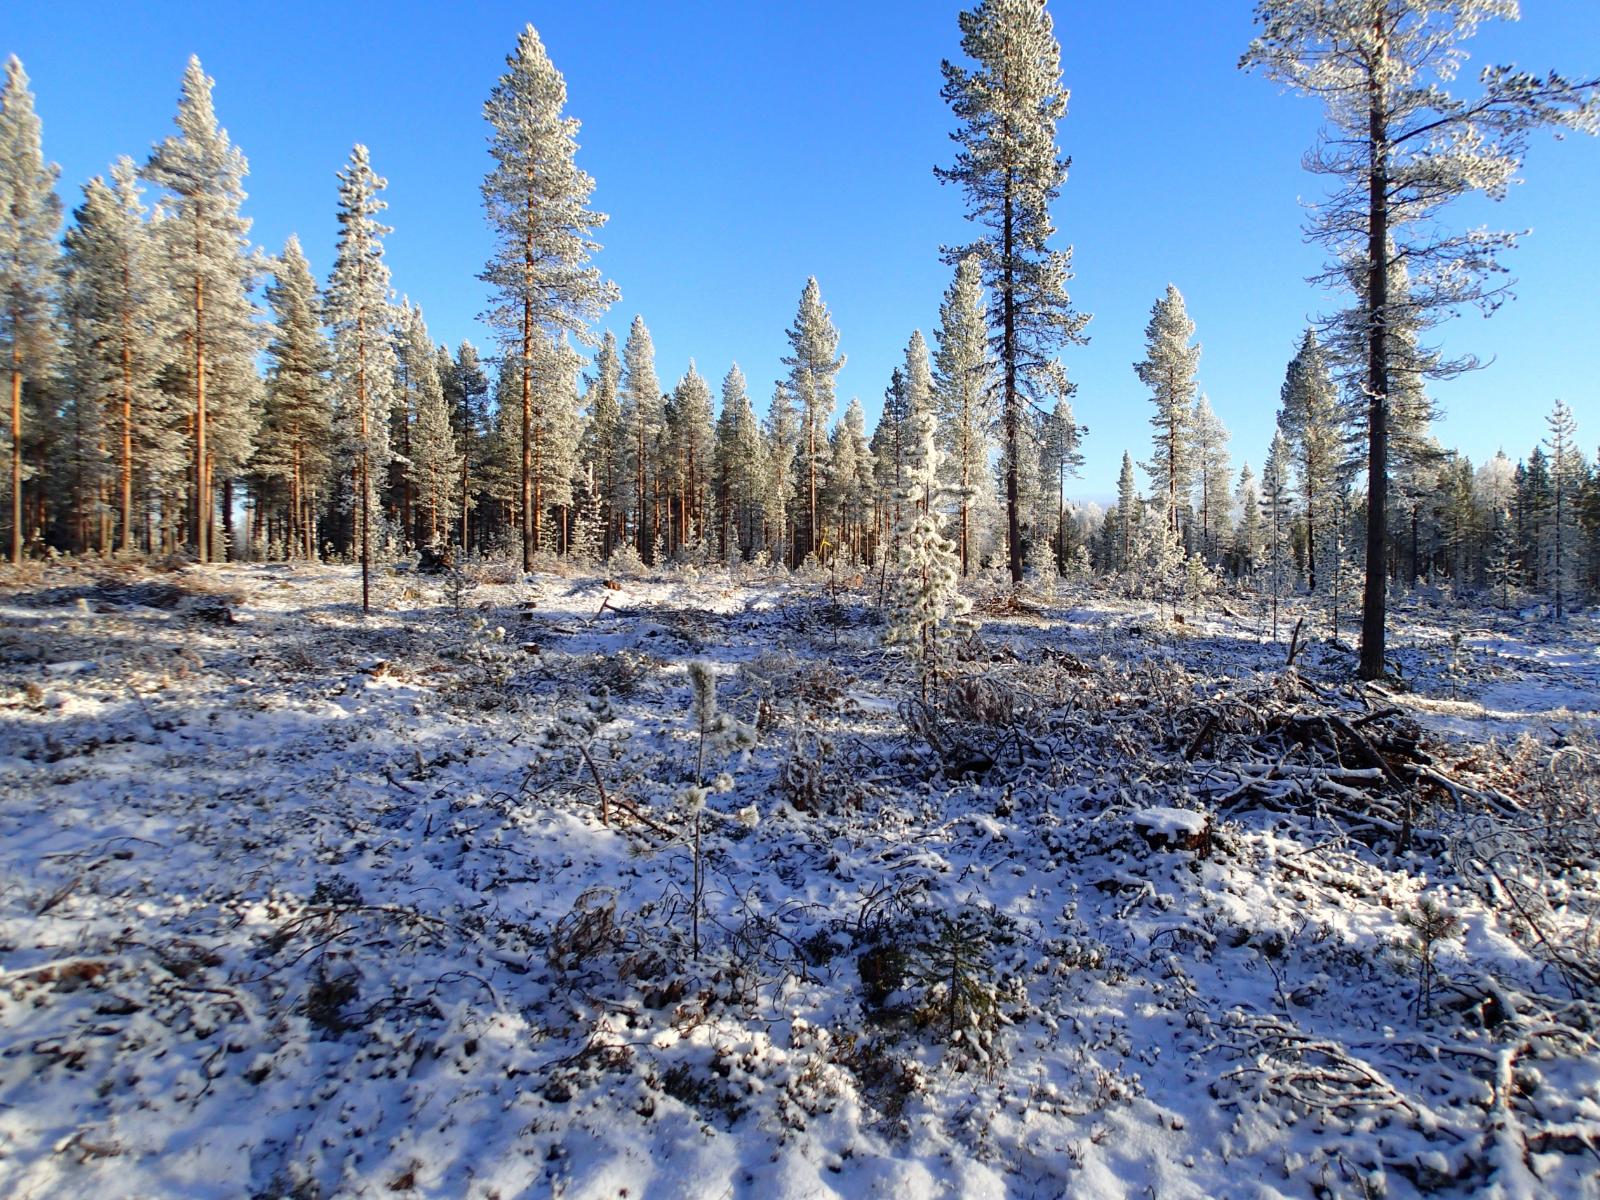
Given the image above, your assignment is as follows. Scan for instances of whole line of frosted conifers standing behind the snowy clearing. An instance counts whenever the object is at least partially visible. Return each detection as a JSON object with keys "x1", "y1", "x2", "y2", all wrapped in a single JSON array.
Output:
[{"x1": 0, "y1": 0, "x2": 1600, "y2": 659}]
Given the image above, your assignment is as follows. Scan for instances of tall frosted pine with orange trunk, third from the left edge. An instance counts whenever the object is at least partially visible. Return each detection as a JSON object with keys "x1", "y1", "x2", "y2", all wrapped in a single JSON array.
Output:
[{"x1": 144, "y1": 58, "x2": 266, "y2": 562}]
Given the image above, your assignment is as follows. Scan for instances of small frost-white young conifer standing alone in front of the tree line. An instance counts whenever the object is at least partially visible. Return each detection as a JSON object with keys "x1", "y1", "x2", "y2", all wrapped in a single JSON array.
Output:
[{"x1": 883, "y1": 380, "x2": 971, "y2": 704}]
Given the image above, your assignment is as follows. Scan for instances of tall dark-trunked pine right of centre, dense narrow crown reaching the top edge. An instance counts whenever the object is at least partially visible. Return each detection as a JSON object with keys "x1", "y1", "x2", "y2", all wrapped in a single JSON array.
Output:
[{"x1": 934, "y1": 0, "x2": 1088, "y2": 584}]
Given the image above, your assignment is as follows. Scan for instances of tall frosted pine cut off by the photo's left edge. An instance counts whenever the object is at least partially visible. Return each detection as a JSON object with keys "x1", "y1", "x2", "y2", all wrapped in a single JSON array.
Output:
[{"x1": 0, "y1": 54, "x2": 61, "y2": 563}]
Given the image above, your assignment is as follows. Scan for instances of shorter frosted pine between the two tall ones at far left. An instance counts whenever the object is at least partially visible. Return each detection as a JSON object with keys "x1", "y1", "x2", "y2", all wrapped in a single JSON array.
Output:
[{"x1": 66, "y1": 158, "x2": 169, "y2": 554}]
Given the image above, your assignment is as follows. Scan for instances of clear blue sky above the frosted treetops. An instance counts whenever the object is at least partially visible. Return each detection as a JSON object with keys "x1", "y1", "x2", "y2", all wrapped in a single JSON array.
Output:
[{"x1": 0, "y1": 0, "x2": 1600, "y2": 496}]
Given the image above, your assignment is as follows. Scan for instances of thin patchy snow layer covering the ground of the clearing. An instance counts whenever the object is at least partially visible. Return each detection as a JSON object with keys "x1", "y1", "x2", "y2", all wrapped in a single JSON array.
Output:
[{"x1": 0, "y1": 566, "x2": 1600, "y2": 1200}]
